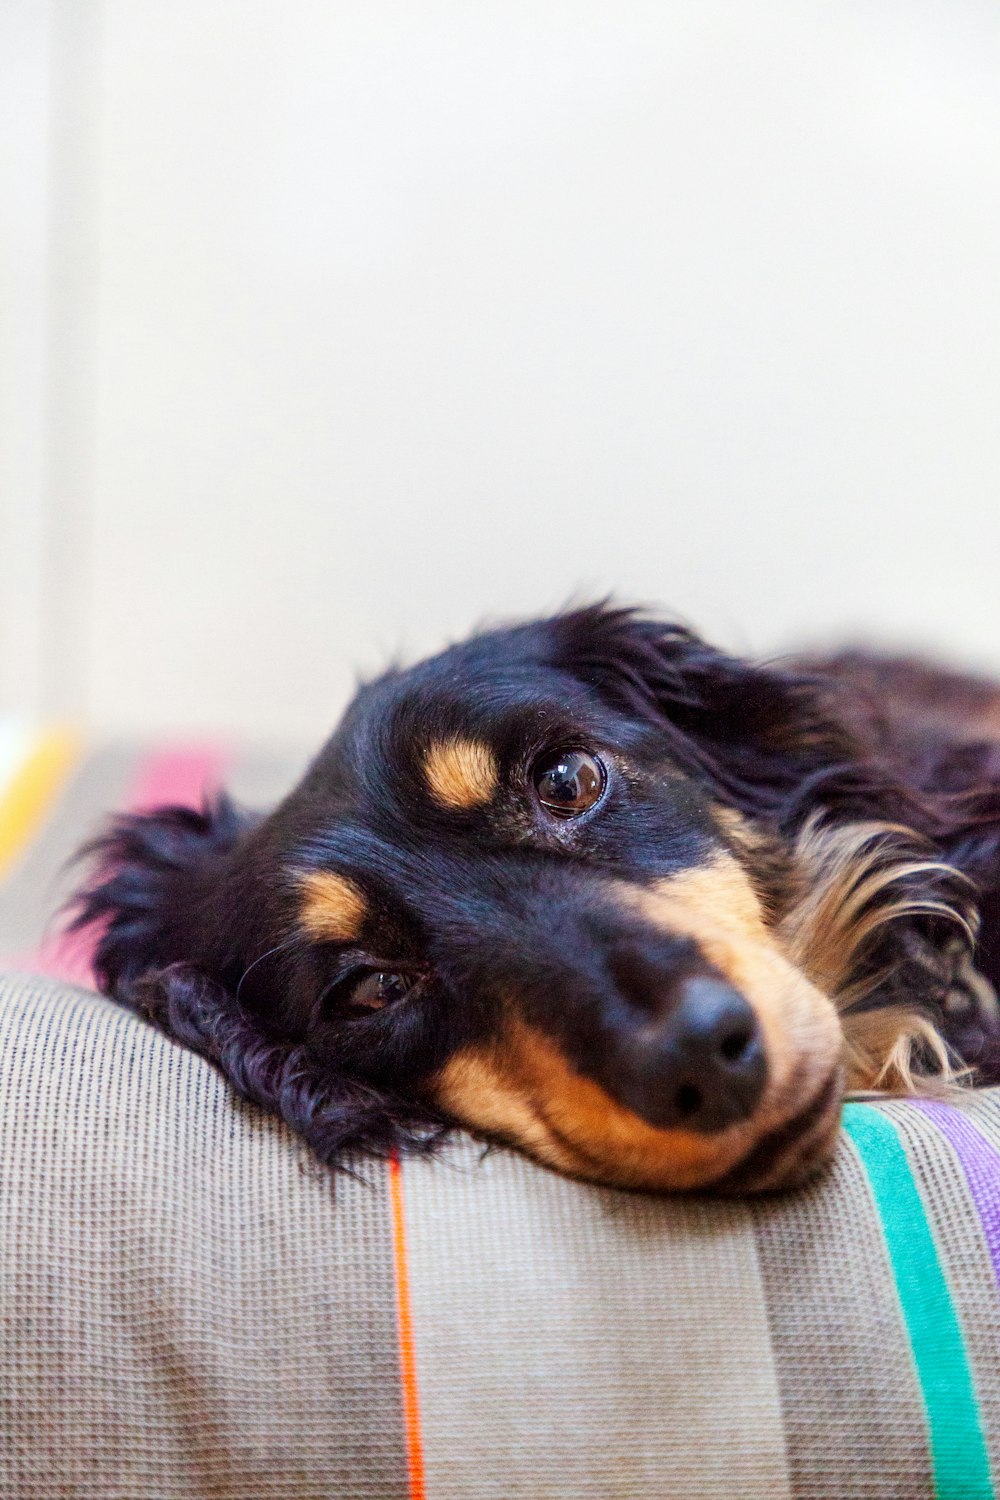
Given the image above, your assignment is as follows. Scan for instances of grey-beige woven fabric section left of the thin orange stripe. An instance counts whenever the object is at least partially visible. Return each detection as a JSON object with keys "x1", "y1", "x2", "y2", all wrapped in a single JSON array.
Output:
[{"x1": 0, "y1": 980, "x2": 406, "y2": 1500}]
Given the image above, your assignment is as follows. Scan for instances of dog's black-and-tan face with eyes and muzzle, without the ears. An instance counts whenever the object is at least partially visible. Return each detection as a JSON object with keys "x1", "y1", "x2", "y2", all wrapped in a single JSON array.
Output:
[{"x1": 226, "y1": 615, "x2": 841, "y2": 1188}]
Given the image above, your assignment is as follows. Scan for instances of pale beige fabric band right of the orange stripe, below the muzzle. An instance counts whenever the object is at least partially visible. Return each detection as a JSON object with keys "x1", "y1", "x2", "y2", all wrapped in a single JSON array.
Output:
[{"x1": 403, "y1": 1143, "x2": 790, "y2": 1500}]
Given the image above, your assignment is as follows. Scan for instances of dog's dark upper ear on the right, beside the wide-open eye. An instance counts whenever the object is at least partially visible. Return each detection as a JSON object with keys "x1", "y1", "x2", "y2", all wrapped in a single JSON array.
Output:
[{"x1": 553, "y1": 605, "x2": 851, "y2": 822}]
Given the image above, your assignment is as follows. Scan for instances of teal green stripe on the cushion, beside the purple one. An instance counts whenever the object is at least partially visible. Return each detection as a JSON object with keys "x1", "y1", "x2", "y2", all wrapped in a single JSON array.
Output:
[{"x1": 844, "y1": 1104, "x2": 993, "y2": 1500}]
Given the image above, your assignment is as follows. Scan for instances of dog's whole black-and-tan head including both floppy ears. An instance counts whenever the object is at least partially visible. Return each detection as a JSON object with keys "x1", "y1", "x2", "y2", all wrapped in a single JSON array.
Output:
[{"x1": 82, "y1": 609, "x2": 977, "y2": 1191}]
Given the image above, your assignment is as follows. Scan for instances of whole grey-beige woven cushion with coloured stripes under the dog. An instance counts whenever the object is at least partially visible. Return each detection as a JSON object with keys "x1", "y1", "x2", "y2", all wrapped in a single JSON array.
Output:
[{"x1": 0, "y1": 723, "x2": 1000, "y2": 1500}]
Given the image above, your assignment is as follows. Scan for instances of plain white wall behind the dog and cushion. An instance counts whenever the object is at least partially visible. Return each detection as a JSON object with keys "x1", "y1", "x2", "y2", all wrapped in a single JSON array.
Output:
[{"x1": 0, "y1": 0, "x2": 1000, "y2": 738}]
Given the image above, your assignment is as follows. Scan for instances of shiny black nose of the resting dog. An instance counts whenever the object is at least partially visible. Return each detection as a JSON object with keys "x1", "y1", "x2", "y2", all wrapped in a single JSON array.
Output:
[{"x1": 615, "y1": 975, "x2": 768, "y2": 1131}]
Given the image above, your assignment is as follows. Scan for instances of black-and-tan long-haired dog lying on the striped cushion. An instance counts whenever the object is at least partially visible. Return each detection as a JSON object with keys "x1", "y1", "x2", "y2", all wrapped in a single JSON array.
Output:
[{"x1": 75, "y1": 606, "x2": 1000, "y2": 1193}]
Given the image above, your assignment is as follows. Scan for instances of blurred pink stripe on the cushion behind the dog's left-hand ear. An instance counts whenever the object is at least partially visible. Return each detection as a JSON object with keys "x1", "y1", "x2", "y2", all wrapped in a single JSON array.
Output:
[{"x1": 6, "y1": 744, "x2": 231, "y2": 986}]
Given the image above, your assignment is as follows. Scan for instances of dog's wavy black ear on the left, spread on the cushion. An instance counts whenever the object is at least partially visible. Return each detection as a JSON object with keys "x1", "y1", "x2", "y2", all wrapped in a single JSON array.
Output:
[{"x1": 69, "y1": 797, "x2": 442, "y2": 1170}]
